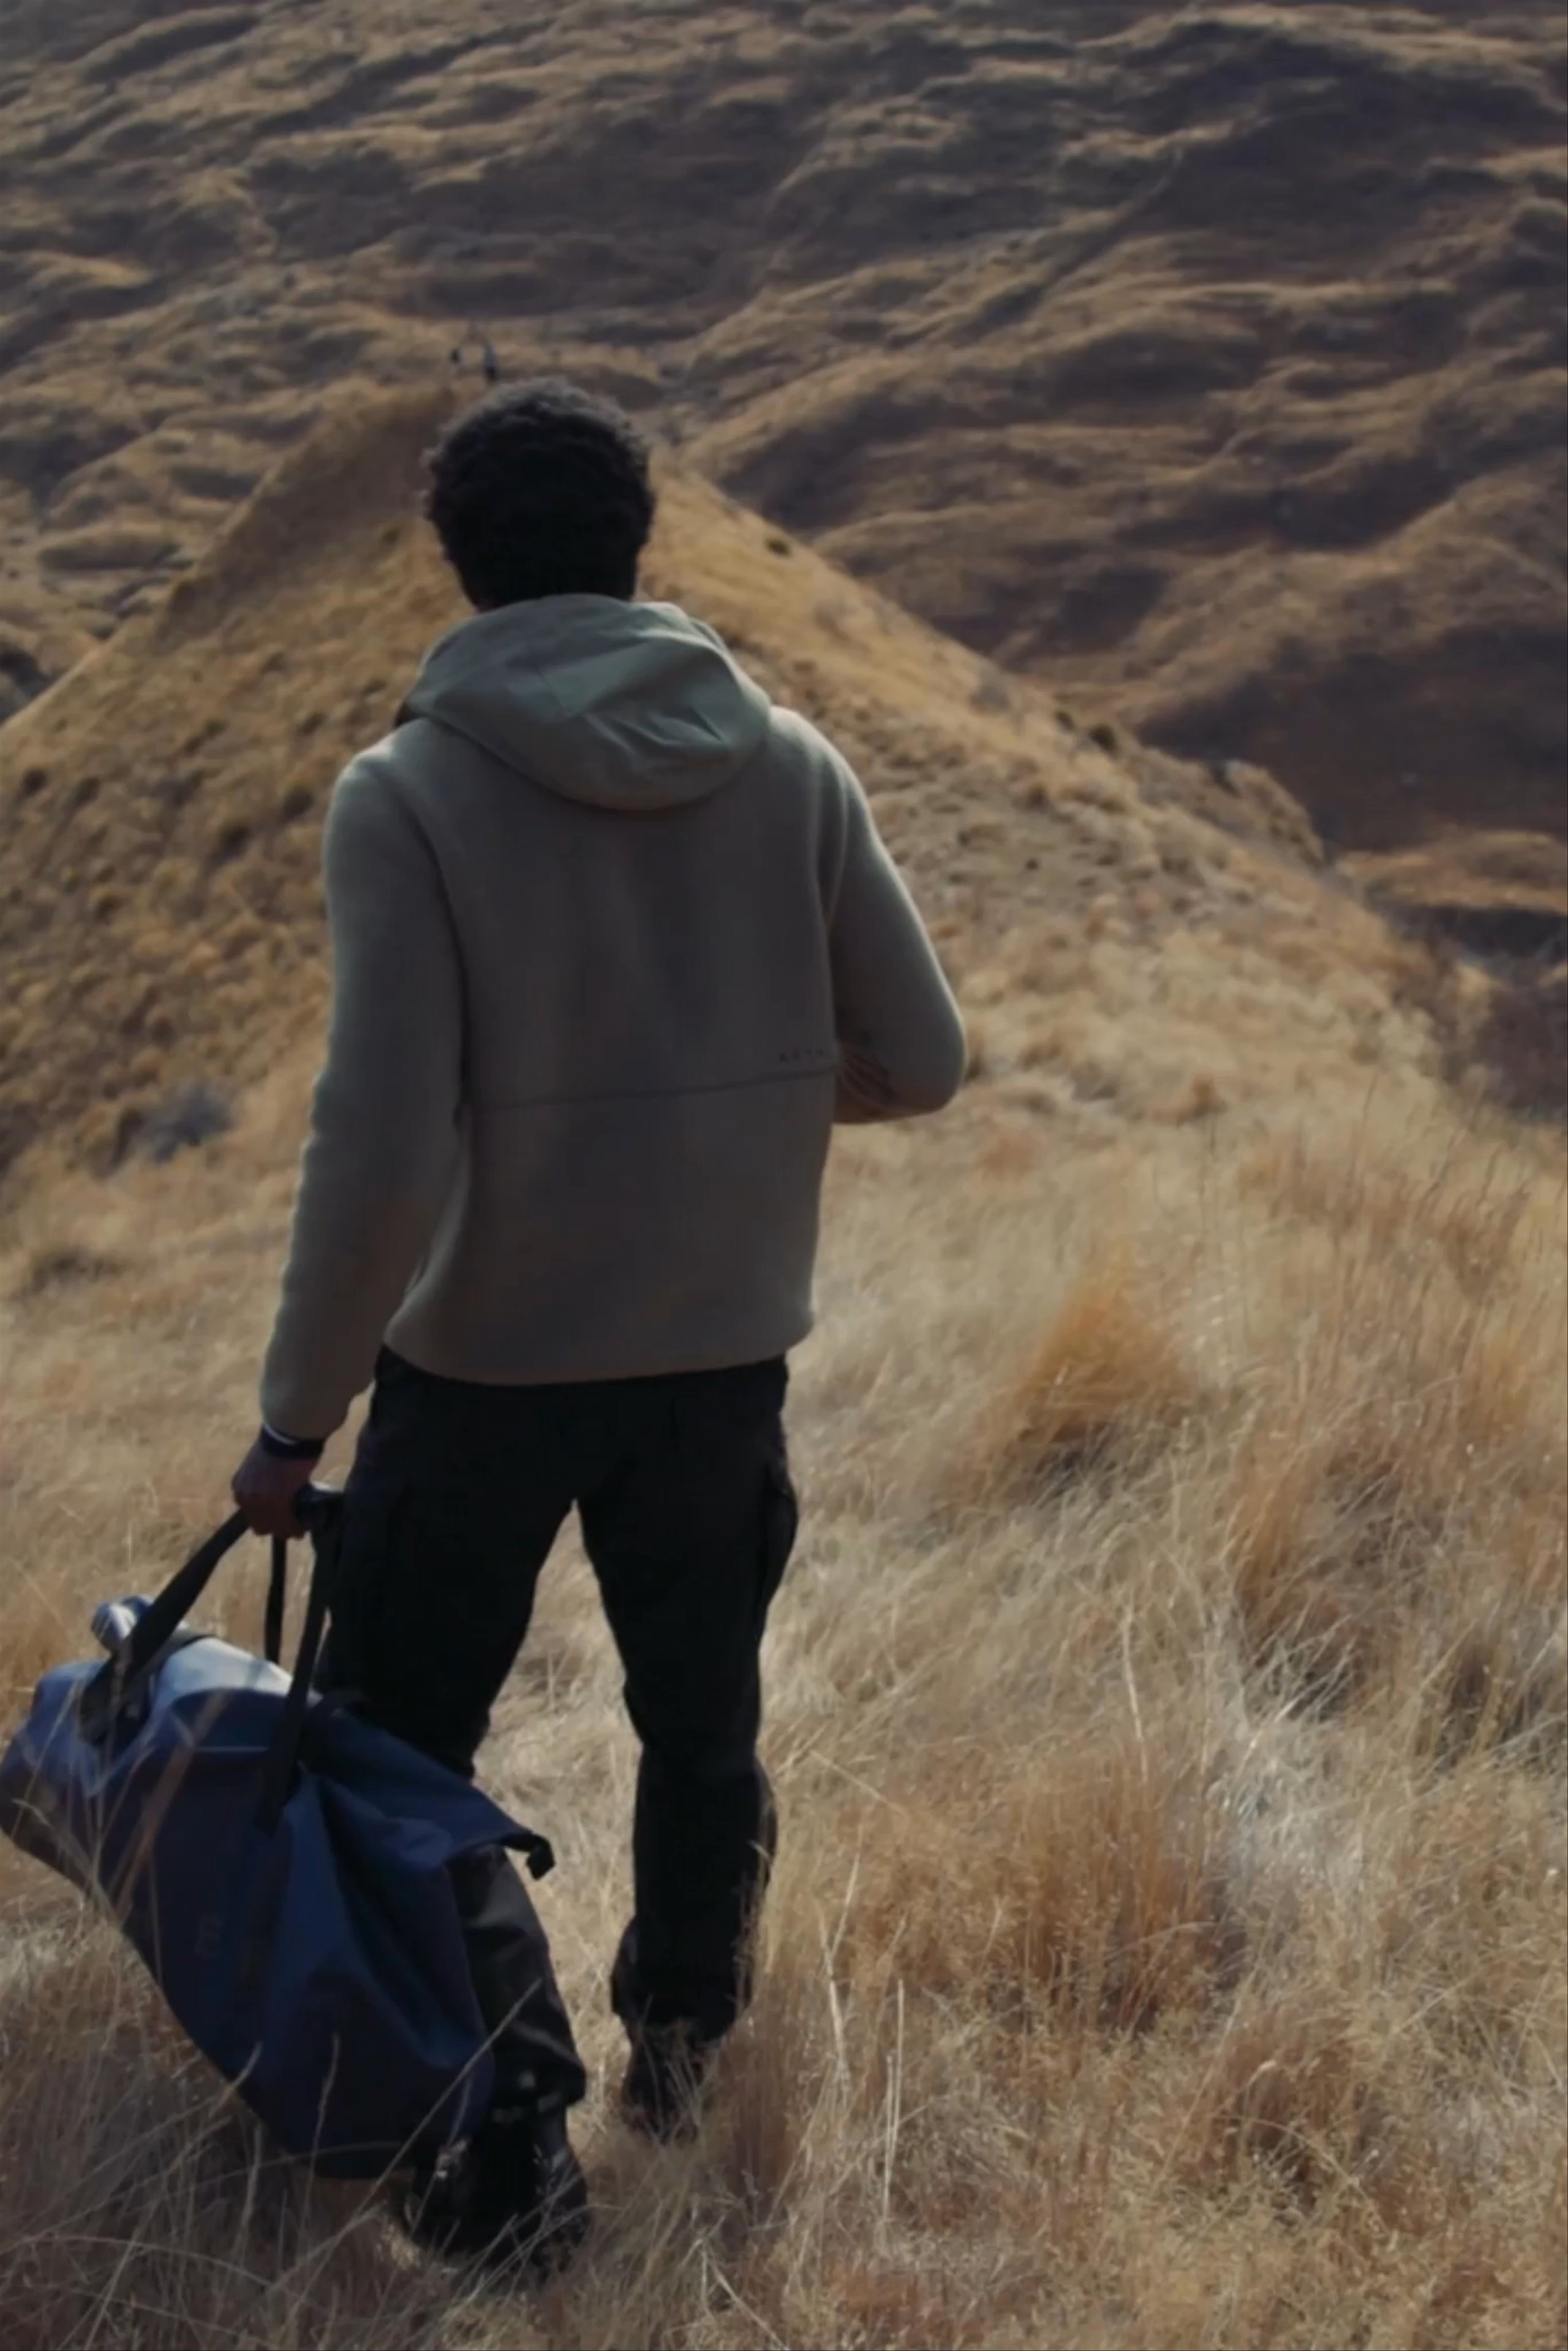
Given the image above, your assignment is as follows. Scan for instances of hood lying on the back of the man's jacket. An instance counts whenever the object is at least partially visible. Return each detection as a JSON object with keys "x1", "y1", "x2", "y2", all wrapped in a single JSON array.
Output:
[{"x1": 399, "y1": 595, "x2": 771, "y2": 813}]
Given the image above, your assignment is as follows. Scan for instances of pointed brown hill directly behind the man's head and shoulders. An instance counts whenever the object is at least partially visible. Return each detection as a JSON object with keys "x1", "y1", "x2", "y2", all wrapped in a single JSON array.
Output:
[{"x1": 12, "y1": 388, "x2": 1513, "y2": 1194}]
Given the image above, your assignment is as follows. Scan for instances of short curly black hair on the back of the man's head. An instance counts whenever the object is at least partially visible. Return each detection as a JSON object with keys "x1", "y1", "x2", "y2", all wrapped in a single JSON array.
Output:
[{"x1": 426, "y1": 379, "x2": 654, "y2": 611}]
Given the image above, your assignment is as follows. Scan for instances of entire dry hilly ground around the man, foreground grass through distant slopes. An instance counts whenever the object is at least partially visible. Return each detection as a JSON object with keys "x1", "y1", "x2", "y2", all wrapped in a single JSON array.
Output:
[{"x1": 0, "y1": 0, "x2": 1568, "y2": 2351}]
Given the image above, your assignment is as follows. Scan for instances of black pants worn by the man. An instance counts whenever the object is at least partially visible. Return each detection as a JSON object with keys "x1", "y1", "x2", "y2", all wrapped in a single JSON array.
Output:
[{"x1": 320, "y1": 1352, "x2": 797, "y2": 2102}]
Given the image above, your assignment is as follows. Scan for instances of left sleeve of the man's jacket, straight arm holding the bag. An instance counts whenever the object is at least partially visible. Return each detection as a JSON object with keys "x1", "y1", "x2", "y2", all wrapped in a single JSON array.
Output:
[{"x1": 261, "y1": 760, "x2": 463, "y2": 1436}]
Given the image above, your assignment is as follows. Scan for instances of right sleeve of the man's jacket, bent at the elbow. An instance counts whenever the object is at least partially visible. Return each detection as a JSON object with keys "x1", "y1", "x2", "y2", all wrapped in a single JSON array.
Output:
[{"x1": 827, "y1": 769, "x2": 968, "y2": 1124}]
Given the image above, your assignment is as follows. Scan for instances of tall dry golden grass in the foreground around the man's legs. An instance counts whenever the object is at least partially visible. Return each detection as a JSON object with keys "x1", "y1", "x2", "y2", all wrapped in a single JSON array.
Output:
[{"x1": 0, "y1": 1055, "x2": 1568, "y2": 2351}]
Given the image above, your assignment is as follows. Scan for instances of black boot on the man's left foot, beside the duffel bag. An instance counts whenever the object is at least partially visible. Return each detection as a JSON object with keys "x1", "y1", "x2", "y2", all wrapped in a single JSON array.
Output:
[{"x1": 399, "y1": 2107, "x2": 590, "y2": 2278}]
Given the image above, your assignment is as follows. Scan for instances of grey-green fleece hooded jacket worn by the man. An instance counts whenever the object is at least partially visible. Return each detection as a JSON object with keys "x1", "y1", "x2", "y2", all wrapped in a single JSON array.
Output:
[{"x1": 261, "y1": 595, "x2": 964, "y2": 1436}]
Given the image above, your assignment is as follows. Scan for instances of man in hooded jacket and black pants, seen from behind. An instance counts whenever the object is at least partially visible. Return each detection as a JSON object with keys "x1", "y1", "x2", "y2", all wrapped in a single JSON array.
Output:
[{"x1": 235, "y1": 383, "x2": 964, "y2": 2257}]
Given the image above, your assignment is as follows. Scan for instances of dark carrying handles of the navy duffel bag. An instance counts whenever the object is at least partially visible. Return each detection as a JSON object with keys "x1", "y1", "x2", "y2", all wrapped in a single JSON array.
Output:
[{"x1": 78, "y1": 1486, "x2": 343, "y2": 1834}]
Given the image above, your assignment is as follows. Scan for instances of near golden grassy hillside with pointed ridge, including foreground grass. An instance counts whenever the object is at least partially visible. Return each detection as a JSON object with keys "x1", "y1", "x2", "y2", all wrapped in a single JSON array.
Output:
[{"x1": 0, "y1": 395, "x2": 1568, "y2": 2351}]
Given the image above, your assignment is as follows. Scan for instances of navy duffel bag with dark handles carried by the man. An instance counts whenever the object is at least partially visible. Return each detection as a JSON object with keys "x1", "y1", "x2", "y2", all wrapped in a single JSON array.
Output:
[{"x1": 0, "y1": 1488, "x2": 550, "y2": 2179}]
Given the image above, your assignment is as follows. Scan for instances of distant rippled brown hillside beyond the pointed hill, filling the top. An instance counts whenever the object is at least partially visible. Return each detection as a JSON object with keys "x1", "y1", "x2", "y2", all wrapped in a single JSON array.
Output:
[{"x1": 0, "y1": 0, "x2": 1568, "y2": 903}]
